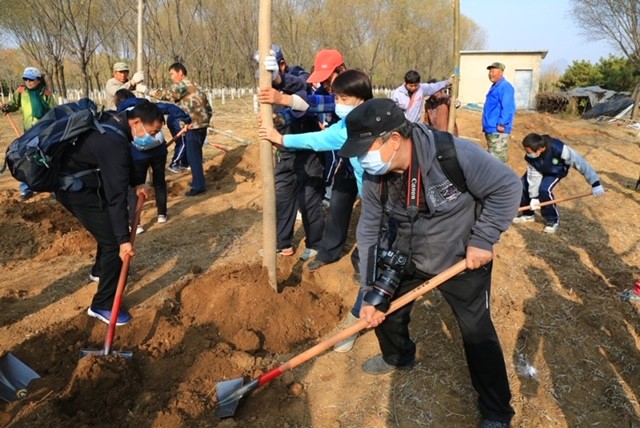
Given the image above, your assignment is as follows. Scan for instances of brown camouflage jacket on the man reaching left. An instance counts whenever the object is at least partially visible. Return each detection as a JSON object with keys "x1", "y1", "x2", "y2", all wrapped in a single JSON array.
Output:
[{"x1": 151, "y1": 78, "x2": 213, "y2": 129}]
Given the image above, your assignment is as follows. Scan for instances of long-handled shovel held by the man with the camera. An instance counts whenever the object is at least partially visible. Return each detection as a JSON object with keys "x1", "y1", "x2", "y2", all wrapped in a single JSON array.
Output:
[{"x1": 216, "y1": 260, "x2": 467, "y2": 418}]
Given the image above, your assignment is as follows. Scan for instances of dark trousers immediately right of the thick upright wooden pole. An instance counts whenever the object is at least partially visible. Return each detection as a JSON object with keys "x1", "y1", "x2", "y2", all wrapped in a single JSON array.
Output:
[{"x1": 274, "y1": 150, "x2": 324, "y2": 249}]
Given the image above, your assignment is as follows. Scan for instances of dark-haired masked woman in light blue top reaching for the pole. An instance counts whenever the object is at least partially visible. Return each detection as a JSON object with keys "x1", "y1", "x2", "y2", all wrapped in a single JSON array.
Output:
[{"x1": 259, "y1": 70, "x2": 373, "y2": 352}]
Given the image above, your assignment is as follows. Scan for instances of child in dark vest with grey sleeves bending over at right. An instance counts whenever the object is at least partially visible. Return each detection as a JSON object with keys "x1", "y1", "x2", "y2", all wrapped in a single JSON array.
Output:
[{"x1": 513, "y1": 133, "x2": 604, "y2": 233}]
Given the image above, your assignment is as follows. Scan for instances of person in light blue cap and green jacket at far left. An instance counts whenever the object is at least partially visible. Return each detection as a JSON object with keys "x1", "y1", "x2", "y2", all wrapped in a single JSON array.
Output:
[{"x1": 0, "y1": 67, "x2": 56, "y2": 201}]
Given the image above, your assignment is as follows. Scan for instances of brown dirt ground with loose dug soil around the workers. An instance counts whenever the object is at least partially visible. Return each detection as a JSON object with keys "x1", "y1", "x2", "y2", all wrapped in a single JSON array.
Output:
[{"x1": 0, "y1": 99, "x2": 640, "y2": 428}]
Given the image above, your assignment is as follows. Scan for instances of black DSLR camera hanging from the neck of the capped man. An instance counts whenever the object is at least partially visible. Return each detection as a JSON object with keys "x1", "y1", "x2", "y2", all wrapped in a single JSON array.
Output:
[{"x1": 364, "y1": 245, "x2": 415, "y2": 312}]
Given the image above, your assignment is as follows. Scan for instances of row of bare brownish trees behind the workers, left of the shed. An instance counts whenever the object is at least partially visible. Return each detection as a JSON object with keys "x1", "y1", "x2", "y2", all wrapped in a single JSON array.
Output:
[{"x1": 0, "y1": 0, "x2": 486, "y2": 93}]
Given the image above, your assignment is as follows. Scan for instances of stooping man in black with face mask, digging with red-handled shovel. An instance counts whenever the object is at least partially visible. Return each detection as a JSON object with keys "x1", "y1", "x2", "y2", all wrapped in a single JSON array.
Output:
[{"x1": 55, "y1": 103, "x2": 164, "y2": 325}]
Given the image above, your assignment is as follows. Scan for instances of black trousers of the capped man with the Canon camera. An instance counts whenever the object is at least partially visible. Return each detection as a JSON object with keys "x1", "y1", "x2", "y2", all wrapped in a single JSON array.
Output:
[{"x1": 375, "y1": 263, "x2": 514, "y2": 422}]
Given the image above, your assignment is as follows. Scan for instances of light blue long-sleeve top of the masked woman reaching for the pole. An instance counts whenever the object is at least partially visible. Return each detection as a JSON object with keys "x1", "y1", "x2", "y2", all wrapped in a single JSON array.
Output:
[{"x1": 282, "y1": 118, "x2": 364, "y2": 194}]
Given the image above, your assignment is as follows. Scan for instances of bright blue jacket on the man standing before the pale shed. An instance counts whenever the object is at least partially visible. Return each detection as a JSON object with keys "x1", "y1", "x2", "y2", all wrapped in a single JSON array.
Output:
[{"x1": 482, "y1": 77, "x2": 516, "y2": 134}]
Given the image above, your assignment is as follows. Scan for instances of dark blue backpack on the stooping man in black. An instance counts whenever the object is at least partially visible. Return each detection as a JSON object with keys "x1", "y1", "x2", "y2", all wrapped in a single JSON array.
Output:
[{"x1": 0, "y1": 98, "x2": 126, "y2": 192}]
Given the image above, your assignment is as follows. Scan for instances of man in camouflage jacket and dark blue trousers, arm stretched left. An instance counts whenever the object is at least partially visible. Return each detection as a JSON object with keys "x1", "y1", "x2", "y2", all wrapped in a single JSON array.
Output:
[{"x1": 150, "y1": 62, "x2": 213, "y2": 196}]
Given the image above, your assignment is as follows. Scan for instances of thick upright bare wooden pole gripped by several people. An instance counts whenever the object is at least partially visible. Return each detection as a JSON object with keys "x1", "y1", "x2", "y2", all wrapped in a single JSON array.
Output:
[{"x1": 258, "y1": 0, "x2": 278, "y2": 293}]
